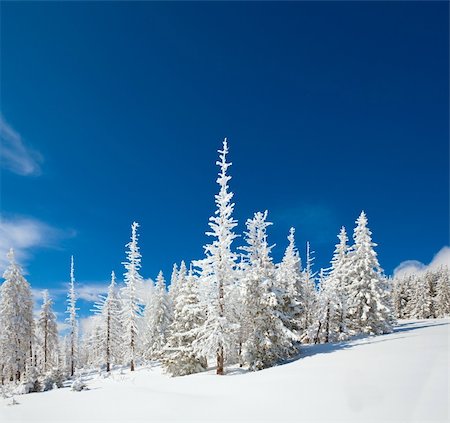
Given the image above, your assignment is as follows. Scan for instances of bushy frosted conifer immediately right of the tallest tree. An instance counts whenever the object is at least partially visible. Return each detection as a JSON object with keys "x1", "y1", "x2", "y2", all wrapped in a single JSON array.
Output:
[{"x1": 241, "y1": 211, "x2": 298, "y2": 370}]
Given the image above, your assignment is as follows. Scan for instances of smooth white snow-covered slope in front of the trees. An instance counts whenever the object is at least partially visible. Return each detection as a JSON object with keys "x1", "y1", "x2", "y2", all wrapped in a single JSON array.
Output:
[{"x1": 0, "y1": 319, "x2": 450, "y2": 423}]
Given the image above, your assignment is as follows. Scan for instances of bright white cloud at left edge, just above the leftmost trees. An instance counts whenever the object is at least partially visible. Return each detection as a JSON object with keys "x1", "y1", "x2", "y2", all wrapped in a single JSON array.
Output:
[{"x1": 0, "y1": 215, "x2": 75, "y2": 270}]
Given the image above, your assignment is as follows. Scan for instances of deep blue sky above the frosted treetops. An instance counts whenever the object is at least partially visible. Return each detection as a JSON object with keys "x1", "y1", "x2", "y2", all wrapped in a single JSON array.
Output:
[{"x1": 0, "y1": 2, "x2": 449, "y2": 324}]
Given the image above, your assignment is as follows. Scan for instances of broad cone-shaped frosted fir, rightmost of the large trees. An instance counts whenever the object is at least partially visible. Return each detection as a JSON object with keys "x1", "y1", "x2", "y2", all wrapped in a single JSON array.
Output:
[{"x1": 348, "y1": 212, "x2": 392, "y2": 334}]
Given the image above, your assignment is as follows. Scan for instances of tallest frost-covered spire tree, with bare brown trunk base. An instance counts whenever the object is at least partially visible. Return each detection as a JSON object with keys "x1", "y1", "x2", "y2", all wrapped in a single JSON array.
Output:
[{"x1": 194, "y1": 138, "x2": 238, "y2": 375}]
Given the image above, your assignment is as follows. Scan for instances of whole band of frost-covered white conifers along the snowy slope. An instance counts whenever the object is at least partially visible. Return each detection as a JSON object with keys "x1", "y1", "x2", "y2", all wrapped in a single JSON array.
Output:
[{"x1": 0, "y1": 139, "x2": 450, "y2": 393}]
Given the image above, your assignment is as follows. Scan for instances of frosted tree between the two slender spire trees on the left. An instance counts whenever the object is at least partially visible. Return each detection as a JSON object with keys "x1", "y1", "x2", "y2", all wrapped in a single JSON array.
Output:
[{"x1": 94, "y1": 271, "x2": 123, "y2": 372}]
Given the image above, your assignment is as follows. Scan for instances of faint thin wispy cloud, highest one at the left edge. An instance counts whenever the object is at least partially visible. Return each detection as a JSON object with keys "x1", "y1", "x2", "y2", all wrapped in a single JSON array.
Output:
[{"x1": 0, "y1": 114, "x2": 43, "y2": 176}]
